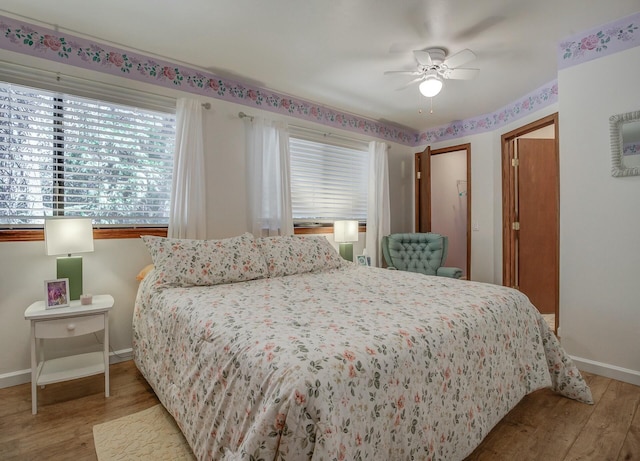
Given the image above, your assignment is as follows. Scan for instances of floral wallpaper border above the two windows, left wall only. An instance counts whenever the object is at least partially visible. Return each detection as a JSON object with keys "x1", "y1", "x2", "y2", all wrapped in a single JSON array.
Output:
[{"x1": 0, "y1": 16, "x2": 416, "y2": 145}]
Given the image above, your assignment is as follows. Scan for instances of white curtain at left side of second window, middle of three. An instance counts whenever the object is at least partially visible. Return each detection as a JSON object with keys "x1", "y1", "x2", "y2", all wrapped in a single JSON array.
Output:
[{"x1": 245, "y1": 117, "x2": 293, "y2": 237}]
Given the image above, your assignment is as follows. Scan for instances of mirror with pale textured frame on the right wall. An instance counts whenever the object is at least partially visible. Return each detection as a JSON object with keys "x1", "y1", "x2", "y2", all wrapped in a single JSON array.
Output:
[{"x1": 609, "y1": 111, "x2": 640, "y2": 176}]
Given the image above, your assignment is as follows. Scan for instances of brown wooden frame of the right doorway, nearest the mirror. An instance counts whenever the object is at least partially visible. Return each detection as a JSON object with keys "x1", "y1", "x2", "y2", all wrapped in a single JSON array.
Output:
[{"x1": 501, "y1": 112, "x2": 560, "y2": 331}]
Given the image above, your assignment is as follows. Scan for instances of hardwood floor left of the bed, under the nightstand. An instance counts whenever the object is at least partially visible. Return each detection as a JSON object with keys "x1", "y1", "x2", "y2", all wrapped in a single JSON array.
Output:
[{"x1": 0, "y1": 360, "x2": 158, "y2": 461}]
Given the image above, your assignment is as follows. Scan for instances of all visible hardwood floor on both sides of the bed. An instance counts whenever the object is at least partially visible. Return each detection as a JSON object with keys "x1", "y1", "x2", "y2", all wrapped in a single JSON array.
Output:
[{"x1": 0, "y1": 361, "x2": 640, "y2": 461}]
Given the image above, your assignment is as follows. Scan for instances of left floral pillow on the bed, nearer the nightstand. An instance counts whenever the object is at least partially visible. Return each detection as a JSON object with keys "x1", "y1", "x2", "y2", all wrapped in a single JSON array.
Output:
[{"x1": 142, "y1": 233, "x2": 268, "y2": 287}]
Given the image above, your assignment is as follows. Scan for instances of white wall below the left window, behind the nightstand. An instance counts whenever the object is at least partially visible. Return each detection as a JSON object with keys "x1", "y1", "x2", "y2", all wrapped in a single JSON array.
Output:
[{"x1": 0, "y1": 235, "x2": 151, "y2": 387}]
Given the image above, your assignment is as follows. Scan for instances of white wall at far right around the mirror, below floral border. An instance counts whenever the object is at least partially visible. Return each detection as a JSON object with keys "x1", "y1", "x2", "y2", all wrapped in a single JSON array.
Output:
[{"x1": 558, "y1": 46, "x2": 640, "y2": 384}]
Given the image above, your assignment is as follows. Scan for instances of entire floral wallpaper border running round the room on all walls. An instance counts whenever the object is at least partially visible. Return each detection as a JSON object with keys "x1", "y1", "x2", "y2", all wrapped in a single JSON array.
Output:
[{"x1": 0, "y1": 13, "x2": 640, "y2": 146}]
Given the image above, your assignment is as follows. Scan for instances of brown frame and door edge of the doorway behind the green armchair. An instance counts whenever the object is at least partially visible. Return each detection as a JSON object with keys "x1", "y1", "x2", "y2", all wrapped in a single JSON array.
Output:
[{"x1": 414, "y1": 143, "x2": 471, "y2": 280}]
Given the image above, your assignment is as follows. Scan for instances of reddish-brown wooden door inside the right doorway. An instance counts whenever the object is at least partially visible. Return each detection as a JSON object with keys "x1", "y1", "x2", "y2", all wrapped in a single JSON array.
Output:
[{"x1": 514, "y1": 138, "x2": 559, "y2": 314}]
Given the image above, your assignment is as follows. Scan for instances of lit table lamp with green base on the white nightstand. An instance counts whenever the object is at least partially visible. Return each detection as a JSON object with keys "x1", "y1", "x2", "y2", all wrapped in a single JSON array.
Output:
[{"x1": 44, "y1": 218, "x2": 93, "y2": 300}]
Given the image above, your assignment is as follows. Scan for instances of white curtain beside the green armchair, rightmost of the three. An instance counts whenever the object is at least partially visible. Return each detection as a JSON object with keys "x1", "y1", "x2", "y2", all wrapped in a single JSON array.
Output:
[{"x1": 366, "y1": 141, "x2": 391, "y2": 267}]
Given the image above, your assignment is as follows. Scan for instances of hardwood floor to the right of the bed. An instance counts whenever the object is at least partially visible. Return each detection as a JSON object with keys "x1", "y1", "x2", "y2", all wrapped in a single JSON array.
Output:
[{"x1": 465, "y1": 373, "x2": 640, "y2": 461}]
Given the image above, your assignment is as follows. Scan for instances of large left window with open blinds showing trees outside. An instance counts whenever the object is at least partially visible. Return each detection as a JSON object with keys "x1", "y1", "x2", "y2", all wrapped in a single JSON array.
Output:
[{"x1": 0, "y1": 82, "x2": 175, "y2": 229}]
